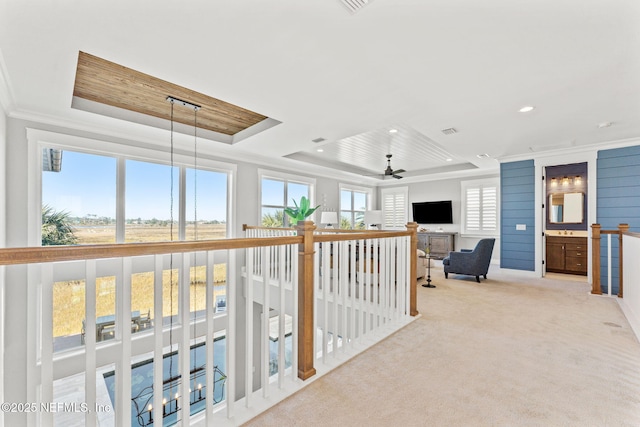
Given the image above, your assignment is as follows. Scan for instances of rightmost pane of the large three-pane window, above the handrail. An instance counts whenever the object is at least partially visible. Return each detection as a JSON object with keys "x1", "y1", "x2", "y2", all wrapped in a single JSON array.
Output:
[{"x1": 186, "y1": 169, "x2": 227, "y2": 240}]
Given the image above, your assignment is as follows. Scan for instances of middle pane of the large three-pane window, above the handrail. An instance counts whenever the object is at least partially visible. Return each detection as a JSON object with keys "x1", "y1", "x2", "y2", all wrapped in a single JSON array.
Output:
[{"x1": 125, "y1": 160, "x2": 179, "y2": 242}]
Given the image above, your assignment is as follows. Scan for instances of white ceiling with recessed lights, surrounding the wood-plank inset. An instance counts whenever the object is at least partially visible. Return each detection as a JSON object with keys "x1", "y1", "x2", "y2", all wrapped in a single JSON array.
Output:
[{"x1": 0, "y1": 0, "x2": 640, "y2": 184}]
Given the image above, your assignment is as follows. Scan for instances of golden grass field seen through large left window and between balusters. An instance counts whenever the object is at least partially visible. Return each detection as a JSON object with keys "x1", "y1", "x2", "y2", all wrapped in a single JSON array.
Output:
[{"x1": 53, "y1": 224, "x2": 227, "y2": 337}]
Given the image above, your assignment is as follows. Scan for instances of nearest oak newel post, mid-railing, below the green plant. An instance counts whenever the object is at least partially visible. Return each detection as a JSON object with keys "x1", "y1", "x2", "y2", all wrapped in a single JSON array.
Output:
[{"x1": 296, "y1": 221, "x2": 316, "y2": 380}]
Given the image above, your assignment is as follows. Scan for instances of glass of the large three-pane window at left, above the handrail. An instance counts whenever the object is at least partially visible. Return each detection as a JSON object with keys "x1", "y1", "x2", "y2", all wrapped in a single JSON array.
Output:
[{"x1": 42, "y1": 147, "x2": 228, "y2": 245}]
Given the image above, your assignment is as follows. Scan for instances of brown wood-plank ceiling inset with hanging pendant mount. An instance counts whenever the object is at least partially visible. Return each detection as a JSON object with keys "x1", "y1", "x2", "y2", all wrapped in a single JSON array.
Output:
[{"x1": 73, "y1": 52, "x2": 267, "y2": 136}]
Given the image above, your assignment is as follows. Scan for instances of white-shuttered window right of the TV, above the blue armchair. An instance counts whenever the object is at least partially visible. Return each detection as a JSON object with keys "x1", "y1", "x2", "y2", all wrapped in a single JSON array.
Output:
[{"x1": 461, "y1": 178, "x2": 499, "y2": 236}]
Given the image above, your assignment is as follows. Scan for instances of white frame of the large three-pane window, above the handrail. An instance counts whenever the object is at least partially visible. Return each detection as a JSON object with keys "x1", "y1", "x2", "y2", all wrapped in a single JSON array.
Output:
[{"x1": 27, "y1": 128, "x2": 237, "y2": 246}]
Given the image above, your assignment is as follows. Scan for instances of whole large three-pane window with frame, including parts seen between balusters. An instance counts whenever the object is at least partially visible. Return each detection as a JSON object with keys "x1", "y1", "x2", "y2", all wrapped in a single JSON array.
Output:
[{"x1": 36, "y1": 130, "x2": 235, "y2": 351}]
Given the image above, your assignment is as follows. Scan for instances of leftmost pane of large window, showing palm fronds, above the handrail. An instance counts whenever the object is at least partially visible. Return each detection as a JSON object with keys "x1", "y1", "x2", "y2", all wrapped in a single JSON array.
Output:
[{"x1": 42, "y1": 148, "x2": 116, "y2": 245}]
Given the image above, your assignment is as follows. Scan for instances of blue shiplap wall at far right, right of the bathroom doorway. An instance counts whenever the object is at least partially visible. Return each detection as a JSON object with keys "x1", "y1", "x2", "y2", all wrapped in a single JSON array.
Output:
[{"x1": 596, "y1": 146, "x2": 640, "y2": 294}]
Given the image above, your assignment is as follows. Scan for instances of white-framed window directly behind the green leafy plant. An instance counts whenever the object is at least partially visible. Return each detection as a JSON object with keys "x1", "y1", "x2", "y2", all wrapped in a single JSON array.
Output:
[{"x1": 260, "y1": 171, "x2": 315, "y2": 227}]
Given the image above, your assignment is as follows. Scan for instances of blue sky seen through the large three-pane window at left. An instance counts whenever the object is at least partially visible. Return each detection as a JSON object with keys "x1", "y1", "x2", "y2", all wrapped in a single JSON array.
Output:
[{"x1": 42, "y1": 150, "x2": 227, "y2": 220}]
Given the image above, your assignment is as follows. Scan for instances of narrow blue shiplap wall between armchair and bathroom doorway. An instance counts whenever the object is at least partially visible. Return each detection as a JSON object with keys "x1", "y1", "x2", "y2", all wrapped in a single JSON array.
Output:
[{"x1": 500, "y1": 160, "x2": 536, "y2": 271}]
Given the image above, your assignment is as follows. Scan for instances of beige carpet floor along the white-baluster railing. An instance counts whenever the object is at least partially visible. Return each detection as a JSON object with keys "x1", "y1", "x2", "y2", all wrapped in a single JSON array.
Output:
[{"x1": 246, "y1": 267, "x2": 640, "y2": 427}]
